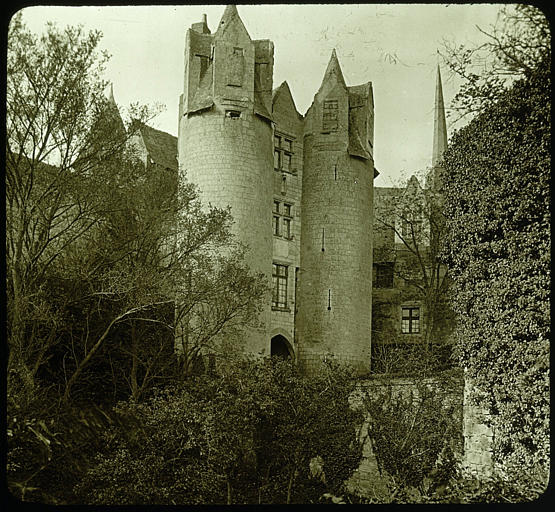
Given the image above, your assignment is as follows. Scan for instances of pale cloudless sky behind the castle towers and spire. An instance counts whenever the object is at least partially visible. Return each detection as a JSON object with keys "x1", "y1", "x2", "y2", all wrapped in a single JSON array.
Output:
[{"x1": 16, "y1": 4, "x2": 501, "y2": 187}]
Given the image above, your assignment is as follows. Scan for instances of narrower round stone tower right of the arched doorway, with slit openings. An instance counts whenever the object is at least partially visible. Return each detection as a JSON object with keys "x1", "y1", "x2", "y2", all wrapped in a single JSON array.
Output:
[{"x1": 296, "y1": 50, "x2": 374, "y2": 374}]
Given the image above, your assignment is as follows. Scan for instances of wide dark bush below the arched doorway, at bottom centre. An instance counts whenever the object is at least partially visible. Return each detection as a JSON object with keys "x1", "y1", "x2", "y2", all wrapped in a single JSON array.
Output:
[{"x1": 71, "y1": 358, "x2": 362, "y2": 505}]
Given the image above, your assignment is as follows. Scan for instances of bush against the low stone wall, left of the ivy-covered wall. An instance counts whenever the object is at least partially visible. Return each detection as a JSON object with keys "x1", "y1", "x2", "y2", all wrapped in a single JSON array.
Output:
[{"x1": 363, "y1": 375, "x2": 462, "y2": 502}]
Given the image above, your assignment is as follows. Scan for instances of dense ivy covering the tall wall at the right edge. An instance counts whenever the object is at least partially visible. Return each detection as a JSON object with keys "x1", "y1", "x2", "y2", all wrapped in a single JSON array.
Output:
[{"x1": 444, "y1": 49, "x2": 551, "y2": 480}]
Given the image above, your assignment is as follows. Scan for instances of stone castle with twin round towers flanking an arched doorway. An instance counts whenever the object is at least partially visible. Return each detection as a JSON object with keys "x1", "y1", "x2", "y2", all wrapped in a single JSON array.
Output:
[{"x1": 122, "y1": 6, "x2": 447, "y2": 374}]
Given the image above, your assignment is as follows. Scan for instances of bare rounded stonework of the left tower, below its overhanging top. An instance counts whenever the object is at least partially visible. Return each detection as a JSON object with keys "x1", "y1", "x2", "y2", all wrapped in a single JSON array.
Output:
[{"x1": 179, "y1": 108, "x2": 273, "y2": 355}]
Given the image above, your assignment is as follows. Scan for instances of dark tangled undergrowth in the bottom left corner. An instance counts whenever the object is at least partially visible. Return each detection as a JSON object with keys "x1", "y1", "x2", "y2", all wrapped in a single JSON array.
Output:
[{"x1": 6, "y1": 379, "x2": 117, "y2": 505}]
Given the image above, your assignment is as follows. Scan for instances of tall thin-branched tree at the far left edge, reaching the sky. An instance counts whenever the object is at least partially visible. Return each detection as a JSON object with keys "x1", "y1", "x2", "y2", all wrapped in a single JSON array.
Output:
[{"x1": 6, "y1": 14, "x2": 154, "y2": 396}]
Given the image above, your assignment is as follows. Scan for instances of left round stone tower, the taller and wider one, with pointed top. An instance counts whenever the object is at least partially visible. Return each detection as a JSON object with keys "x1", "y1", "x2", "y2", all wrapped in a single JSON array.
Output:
[{"x1": 178, "y1": 6, "x2": 273, "y2": 354}]
